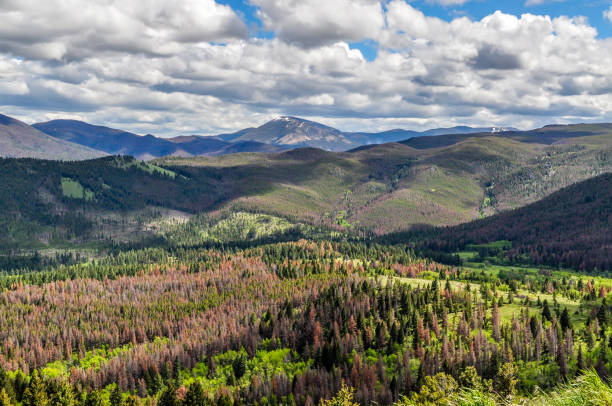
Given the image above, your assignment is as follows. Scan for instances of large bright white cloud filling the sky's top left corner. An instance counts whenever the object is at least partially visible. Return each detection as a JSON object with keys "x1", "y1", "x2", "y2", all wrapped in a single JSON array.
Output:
[{"x1": 0, "y1": 0, "x2": 247, "y2": 60}]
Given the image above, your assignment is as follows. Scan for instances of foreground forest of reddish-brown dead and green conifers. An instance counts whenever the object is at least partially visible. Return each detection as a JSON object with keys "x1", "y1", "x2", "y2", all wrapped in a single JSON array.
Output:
[{"x1": 0, "y1": 233, "x2": 612, "y2": 405}]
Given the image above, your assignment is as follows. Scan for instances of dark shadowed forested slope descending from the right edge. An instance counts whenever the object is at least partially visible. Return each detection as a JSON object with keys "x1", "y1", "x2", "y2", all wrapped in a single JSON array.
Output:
[{"x1": 402, "y1": 173, "x2": 612, "y2": 270}]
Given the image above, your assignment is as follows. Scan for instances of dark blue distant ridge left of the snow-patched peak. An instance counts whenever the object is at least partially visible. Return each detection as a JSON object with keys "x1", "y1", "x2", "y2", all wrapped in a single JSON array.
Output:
[{"x1": 34, "y1": 120, "x2": 281, "y2": 160}]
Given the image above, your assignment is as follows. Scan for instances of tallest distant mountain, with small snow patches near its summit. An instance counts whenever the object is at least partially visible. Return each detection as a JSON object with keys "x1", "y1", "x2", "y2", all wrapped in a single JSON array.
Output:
[{"x1": 232, "y1": 116, "x2": 516, "y2": 151}]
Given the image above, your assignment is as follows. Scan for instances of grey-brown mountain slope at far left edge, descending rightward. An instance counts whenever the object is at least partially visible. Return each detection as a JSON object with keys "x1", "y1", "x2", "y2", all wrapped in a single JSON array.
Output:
[{"x1": 0, "y1": 114, "x2": 106, "y2": 160}]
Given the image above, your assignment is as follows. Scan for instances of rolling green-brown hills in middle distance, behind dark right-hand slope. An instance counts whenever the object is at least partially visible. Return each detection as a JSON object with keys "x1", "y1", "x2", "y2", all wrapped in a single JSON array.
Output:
[{"x1": 157, "y1": 128, "x2": 612, "y2": 233}]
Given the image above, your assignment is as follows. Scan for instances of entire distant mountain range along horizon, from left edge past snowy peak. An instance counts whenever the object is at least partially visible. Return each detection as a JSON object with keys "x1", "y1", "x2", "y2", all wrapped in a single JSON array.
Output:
[{"x1": 0, "y1": 116, "x2": 514, "y2": 160}]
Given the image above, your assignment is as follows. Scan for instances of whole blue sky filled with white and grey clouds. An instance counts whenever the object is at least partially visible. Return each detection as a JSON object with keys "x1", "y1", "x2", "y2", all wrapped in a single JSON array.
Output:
[{"x1": 0, "y1": 0, "x2": 612, "y2": 136}]
